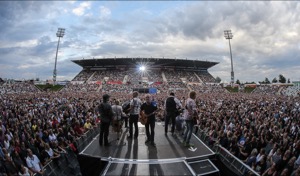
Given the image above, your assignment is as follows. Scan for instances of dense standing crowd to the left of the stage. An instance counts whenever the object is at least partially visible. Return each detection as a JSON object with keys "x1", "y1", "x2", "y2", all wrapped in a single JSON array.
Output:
[{"x1": 0, "y1": 88, "x2": 100, "y2": 175}]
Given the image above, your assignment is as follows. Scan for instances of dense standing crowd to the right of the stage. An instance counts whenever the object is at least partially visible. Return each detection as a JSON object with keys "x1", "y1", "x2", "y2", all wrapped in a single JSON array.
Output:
[{"x1": 198, "y1": 93, "x2": 300, "y2": 174}]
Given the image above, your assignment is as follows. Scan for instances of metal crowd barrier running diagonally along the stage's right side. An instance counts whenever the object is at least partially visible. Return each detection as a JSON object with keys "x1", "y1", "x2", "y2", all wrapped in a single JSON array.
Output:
[{"x1": 196, "y1": 130, "x2": 259, "y2": 176}]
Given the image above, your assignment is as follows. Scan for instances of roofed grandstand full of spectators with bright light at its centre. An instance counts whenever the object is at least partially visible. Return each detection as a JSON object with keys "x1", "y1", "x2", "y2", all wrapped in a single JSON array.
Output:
[{"x1": 67, "y1": 58, "x2": 218, "y2": 92}]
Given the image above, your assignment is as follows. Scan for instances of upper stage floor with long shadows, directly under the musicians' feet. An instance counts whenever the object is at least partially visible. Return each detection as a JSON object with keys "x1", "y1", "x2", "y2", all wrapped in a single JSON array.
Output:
[{"x1": 81, "y1": 122, "x2": 214, "y2": 160}]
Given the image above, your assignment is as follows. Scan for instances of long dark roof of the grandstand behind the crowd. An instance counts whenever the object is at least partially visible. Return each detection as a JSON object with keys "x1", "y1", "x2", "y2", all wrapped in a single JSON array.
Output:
[{"x1": 72, "y1": 58, "x2": 219, "y2": 70}]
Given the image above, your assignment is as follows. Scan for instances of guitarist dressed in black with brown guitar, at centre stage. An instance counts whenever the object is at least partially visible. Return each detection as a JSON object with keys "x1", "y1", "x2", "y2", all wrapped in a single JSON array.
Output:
[{"x1": 140, "y1": 94, "x2": 157, "y2": 147}]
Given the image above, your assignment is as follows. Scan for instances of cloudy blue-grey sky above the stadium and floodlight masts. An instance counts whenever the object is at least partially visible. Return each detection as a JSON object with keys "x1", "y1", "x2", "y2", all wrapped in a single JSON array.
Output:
[{"x1": 0, "y1": 1, "x2": 300, "y2": 82}]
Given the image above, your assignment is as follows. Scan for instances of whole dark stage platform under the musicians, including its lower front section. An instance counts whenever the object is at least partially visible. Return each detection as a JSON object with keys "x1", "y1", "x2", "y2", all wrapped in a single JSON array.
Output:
[{"x1": 79, "y1": 122, "x2": 219, "y2": 175}]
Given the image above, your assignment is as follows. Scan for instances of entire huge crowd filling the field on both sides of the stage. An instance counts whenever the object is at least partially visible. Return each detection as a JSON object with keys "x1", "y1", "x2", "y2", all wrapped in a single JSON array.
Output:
[{"x1": 0, "y1": 69, "x2": 300, "y2": 175}]
